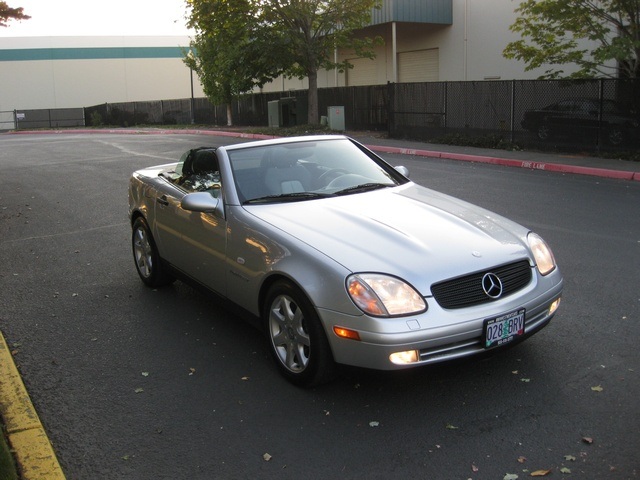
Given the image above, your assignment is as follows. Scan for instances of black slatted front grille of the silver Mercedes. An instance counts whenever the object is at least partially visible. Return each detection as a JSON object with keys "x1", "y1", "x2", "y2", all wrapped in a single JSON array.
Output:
[{"x1": 431, "y1": 260, "x2": 531, "y2": 308}]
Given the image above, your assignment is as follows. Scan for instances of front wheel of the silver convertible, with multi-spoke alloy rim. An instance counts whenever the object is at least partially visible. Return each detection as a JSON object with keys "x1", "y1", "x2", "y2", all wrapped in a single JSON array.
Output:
[{"x1": 263, "y1": 281, "x2": 335, "y2": 387}]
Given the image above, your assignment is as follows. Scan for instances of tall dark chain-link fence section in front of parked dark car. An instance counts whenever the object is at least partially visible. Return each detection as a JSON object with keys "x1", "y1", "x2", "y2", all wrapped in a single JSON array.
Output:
[{"x1": 389, "y1": 80, "x2": 640, "y2": 150}]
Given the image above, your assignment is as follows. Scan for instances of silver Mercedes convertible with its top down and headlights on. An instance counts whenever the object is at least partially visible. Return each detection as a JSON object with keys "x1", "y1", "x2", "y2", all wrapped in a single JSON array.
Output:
[{"x1": 129, "y1": 135, "x2": 563, "y2": 386}]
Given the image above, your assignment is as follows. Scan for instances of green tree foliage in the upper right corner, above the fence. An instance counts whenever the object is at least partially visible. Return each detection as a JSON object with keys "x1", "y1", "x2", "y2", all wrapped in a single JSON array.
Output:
[{"x1": 503, "y1": 0, "x2": 640, "y2": 78}]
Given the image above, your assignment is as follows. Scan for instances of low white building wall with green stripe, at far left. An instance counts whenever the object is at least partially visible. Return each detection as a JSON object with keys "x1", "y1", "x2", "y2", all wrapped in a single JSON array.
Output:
[{"x1": 0, "y1": 37, "x2": 204, "y2": 111}]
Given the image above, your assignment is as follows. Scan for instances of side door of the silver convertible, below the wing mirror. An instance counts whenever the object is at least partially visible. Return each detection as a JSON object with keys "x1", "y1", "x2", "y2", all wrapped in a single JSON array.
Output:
[{"x1": 155, "y1": 169, "x2": 227, "y2": 296}]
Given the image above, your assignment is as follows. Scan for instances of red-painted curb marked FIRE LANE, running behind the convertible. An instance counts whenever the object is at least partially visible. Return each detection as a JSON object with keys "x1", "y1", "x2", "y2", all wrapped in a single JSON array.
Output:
[{"x1": 9, "y1": 128, "x2": 640, "y2": 182}]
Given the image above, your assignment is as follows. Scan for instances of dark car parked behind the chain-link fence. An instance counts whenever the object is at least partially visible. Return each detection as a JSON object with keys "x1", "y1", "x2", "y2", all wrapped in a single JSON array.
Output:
[{"x1": 520, "y1": 98, "x2": 640, "y2": 146}]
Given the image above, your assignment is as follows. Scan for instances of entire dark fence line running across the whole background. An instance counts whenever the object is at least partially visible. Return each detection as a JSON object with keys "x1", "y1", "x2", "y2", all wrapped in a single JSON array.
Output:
[{"x1": 6, "y1": 79, "x2": 640, "y2": 151}]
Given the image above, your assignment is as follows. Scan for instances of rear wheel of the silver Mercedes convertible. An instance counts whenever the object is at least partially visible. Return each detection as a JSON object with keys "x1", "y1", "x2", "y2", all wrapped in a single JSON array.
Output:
[{"x1": 131, "y1": 217, "x2": 175, "y2": 288}]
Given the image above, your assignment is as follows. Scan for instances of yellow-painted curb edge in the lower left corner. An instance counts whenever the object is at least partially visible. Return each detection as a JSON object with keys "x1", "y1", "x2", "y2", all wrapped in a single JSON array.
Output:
[{"x1": 0, "y1": 332, "x2": 65, "y2": 480}]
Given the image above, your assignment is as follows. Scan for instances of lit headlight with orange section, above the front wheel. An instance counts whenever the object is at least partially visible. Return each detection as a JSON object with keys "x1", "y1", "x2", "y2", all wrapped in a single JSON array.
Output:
[{"x1": 347, "y1": 273, "x2": 427, "y2": 317}]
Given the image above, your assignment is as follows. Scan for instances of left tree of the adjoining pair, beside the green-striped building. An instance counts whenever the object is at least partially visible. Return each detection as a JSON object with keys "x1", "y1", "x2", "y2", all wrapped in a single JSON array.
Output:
[{"x1": 184, "y1": 0, "x2": 282, "y2": 125}]
